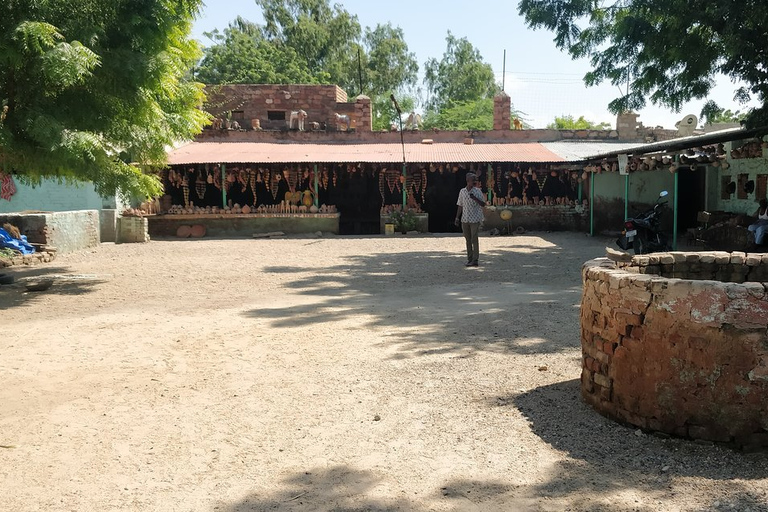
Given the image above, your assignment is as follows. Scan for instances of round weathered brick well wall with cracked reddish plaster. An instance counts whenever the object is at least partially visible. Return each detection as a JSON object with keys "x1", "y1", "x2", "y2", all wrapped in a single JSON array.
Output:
[{"x1": 581, "y1": 251, "x2": 768, "y2": 449}]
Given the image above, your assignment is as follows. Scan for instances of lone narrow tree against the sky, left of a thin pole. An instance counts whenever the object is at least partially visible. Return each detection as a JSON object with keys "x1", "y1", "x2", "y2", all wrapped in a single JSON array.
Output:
[{"x1": 424, "y1": 32, "x2": 499, "y2": 111}]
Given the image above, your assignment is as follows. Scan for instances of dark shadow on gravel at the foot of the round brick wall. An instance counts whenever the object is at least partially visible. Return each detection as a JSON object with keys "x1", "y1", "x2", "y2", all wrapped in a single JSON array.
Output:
[{"x1": 508, "y1": 380, "x2": 768, "y2": 511}]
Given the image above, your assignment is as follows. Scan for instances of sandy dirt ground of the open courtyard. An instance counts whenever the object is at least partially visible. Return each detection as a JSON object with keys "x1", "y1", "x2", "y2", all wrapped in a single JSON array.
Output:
[{"x1": 0, "y1": 234, "x2": 768, "y2": 512}]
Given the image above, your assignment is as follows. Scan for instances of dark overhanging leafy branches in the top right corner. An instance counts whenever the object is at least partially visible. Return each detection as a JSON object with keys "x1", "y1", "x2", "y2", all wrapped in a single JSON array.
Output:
[{"x1": 519, "y1": 0, "x2": 768, "y2": 125}]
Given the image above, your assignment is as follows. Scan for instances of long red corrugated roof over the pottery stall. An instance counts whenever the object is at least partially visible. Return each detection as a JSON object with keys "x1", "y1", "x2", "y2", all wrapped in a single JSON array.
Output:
[{"x1": 168, "y1": 142, "x2": 564, "y2": 165}]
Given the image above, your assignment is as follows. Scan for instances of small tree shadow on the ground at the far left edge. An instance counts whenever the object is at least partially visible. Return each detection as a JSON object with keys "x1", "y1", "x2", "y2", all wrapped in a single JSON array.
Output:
[{"x1": 0, "y1": 267, "x2": 104, "y2": 310}]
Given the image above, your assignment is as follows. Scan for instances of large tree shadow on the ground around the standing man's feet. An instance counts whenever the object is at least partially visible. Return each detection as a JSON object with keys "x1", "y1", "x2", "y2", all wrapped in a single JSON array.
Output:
[{"x1": 244, "y1": 235, "x2": 604, "y2": 358}]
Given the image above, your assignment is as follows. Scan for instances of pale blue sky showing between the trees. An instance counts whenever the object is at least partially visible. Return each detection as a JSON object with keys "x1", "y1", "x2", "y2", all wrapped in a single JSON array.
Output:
[{"x1": 192, "y1": 0, "x2": 744, "y2": 129}]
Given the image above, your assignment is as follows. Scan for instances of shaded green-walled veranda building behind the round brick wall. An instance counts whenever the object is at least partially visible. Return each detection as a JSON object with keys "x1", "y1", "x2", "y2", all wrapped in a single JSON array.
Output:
[{"x1": 585, "y1": 128, "x2": 768, "y2": 252}]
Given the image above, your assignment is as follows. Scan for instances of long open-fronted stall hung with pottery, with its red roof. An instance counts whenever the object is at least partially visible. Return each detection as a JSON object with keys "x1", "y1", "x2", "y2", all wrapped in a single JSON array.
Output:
[{"x1": 162, "y1": 143, "x2": 587, "y2": 235}]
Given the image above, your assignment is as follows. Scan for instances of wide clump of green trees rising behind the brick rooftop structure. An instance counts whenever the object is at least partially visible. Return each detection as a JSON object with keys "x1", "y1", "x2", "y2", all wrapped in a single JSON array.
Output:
[{"x1": 197, "y1": 0, "x2": 419, "y2": 130}]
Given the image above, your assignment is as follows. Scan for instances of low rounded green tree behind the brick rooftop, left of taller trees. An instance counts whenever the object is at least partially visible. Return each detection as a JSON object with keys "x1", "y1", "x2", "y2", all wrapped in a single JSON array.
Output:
[{"x1": 196, "y1": 17, "x2": 322, "y2": 84}]
